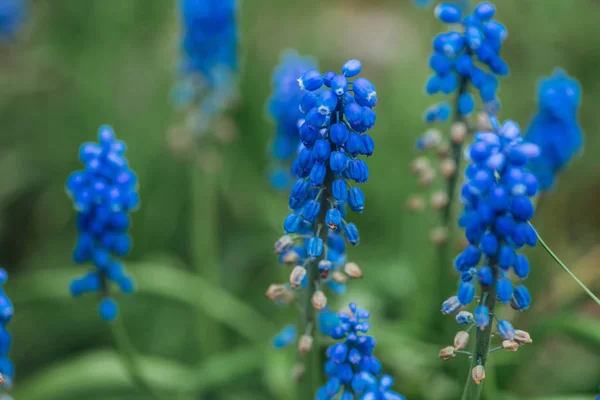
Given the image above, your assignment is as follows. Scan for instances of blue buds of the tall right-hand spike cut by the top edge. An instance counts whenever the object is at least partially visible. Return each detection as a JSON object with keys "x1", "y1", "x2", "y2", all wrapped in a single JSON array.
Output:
[{"x1": 425, "y1": 2, "x2": 508, "y2": 122}]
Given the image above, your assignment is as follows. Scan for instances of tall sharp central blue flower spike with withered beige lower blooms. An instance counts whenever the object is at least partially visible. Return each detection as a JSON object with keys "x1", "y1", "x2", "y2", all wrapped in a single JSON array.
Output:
[{"x1": 267, "y1": 60, "x2": 377, "y2": 360}]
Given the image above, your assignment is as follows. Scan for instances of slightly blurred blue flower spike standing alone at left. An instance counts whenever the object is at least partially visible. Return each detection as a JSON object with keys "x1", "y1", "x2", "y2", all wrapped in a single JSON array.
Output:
[{"x1": 66, "y1": 126, "x2": 140, "y2": 321}]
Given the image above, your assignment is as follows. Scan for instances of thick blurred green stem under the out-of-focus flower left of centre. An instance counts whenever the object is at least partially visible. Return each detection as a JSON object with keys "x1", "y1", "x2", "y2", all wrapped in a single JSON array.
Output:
[{"x1": 189, "y1": 152, "x2": 223, "y2": 359}]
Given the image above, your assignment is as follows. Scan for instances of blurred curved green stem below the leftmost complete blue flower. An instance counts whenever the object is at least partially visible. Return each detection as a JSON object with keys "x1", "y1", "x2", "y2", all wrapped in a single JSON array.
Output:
[{"x1": 109, "y1": 317, "x2": 169, "y2": 400}]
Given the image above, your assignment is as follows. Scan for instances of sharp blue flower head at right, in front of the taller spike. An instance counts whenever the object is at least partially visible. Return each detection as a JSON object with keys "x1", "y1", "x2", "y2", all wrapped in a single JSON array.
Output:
[{"x1": 442, "y1": 117, "x2": 540, "y2": 329}]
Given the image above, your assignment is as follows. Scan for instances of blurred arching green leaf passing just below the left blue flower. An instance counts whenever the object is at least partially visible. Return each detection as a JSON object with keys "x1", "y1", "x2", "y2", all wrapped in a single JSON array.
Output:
[{"x1": 7, "y1": 260, "x2": 277, "y2": 342}]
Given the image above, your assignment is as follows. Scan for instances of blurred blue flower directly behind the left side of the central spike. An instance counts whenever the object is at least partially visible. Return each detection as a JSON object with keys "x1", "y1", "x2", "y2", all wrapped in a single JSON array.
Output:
[{"x1": 267, "y1": 50, "x2": 315, "y2": 190}]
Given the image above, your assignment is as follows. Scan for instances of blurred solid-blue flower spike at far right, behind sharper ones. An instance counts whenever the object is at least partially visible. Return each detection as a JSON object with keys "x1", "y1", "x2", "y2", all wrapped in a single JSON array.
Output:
[{"x1": 525, "y1": 69, "x2": 583, "y2": 190}]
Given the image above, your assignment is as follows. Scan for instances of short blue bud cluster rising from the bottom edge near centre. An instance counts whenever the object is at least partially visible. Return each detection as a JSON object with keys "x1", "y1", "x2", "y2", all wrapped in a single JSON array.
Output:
[{"x1": 315, "y1": 303, "x2": 405, "y2": 400}]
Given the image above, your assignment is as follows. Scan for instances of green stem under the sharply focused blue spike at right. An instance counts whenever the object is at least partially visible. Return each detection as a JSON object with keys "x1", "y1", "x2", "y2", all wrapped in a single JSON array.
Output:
[{"x1": 462, "y1": 258, "x2": 498, "y2": 400}]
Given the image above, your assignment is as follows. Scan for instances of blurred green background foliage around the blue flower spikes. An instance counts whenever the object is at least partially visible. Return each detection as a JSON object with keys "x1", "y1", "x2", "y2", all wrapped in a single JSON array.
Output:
[{"x1": 0, "y1": 0, "x2": 600, "y2": 400}]
